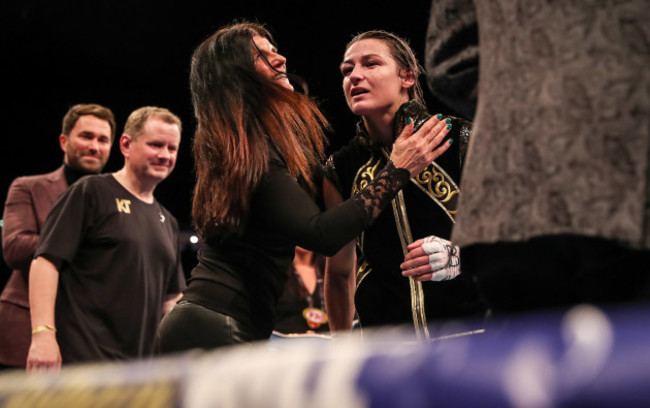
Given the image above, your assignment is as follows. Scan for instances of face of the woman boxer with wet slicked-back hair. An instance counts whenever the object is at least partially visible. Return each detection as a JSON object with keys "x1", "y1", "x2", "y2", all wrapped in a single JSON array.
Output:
[{"x1": 341, "y1": 38, "x2": 414, "y2": 116}]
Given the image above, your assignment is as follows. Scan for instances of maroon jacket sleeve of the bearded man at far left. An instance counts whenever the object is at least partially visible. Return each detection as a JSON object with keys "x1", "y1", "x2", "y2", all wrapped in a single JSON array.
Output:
[{"x1": 2, "y1": 179, "x2": 38, "y2": 280}]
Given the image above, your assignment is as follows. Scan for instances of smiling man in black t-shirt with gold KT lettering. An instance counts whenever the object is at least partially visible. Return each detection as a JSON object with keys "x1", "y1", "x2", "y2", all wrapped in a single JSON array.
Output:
[{"x1": 27, "y1": 107, "x2": 184, "y2": 371}]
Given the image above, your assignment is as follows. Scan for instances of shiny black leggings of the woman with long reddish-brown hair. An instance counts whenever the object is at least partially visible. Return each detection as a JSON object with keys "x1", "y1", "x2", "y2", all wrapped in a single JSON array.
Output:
[{"x1": 155, "y1": 300, "x2": 253, "y2": 354}]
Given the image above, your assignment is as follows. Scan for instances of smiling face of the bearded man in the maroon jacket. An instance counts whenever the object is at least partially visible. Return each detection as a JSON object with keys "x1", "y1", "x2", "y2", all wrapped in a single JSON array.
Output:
[{"x1": 59, "y1": 115, "x2": 111, "y2": 173}]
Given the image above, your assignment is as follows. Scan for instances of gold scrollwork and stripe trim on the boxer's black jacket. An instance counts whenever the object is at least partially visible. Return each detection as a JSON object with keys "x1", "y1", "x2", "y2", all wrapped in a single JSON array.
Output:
[{"x1": 352, "y1": 148, "x2": 460, "y2": 340}]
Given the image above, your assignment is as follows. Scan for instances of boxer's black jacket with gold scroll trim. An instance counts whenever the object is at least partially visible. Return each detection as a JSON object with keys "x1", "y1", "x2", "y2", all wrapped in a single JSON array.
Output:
[{"x1": 326, "y1": 101, "x2": 483, "y2": 336}]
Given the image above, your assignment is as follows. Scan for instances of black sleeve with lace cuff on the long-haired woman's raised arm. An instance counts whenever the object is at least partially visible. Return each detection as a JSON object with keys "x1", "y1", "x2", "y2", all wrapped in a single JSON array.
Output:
[{"x1": 254, "y1": 155, "x2": 409, "y2": 256}]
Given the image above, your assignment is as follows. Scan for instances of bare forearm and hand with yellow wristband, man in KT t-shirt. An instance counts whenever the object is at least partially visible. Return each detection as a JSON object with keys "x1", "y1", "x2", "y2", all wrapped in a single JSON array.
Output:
[{"x1": 27, "y1": 256, "x2": 61, "y2": 372}]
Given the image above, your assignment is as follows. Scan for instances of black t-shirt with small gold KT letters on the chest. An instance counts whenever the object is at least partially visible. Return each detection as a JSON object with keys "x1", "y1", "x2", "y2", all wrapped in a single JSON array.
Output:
[{"x1": 36, "y1": 174, "x2": 185, "y2": 363}]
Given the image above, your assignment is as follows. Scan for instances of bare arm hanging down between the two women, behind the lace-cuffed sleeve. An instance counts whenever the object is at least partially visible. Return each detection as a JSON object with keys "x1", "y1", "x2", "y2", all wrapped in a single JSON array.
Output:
[{"x1": 323, "y1": 178, "x2": 355, "y2": 332}]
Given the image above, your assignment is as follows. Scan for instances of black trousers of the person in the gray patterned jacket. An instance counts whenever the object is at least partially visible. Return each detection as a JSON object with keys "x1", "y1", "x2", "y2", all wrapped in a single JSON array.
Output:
[{"x1": 461, "y1": 235, "x2": 650, "y2": 315}]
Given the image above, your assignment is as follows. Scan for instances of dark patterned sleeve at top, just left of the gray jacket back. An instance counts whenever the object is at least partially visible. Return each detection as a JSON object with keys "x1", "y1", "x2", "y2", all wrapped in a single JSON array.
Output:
[{"x1": 425, "y1": 0, "x2": 479, "y2": 120}]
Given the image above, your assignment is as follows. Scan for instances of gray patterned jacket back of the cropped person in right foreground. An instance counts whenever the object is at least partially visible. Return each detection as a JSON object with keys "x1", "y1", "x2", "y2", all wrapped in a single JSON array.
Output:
[{"x1": 442, "y1": 0, "x2": 650, "y2": 248}]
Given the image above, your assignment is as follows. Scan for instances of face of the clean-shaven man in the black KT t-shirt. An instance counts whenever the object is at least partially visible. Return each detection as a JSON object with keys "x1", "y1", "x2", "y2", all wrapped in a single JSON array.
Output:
[{"x1": 122, "y1": 117, "x2": 181, "y2": 183}]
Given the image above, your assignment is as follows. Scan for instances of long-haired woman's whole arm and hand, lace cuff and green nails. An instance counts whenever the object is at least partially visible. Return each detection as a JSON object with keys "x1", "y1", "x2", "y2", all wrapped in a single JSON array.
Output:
[{"x1": 254, "y1": 117, "x2": 449, "y2": 256}]
